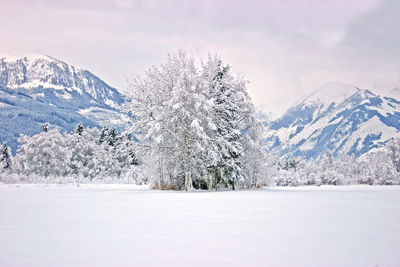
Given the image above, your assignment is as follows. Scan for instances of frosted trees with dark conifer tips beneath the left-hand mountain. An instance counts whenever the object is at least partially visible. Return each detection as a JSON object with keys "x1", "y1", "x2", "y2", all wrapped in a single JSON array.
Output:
[{"x1": 0, "y1": 124, "x2": 144, "y2": 183}]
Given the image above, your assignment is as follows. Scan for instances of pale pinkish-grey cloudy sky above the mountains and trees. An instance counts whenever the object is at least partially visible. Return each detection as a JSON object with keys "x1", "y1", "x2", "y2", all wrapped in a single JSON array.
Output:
[{"x1": 0, "y1": 0, "x2": 400, "y2": 115}]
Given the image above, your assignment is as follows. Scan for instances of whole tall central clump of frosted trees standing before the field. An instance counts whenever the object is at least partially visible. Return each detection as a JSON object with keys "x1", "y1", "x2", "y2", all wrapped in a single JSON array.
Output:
[{"x1": 125, "y1": 52, "x2": 253, "y2": 190}]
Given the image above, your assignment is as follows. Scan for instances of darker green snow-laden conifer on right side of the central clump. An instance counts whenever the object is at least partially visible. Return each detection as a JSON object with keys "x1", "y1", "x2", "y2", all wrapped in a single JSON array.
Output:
[{"x1": 202, "y1": 56, "x2": 259, "y2": 189}]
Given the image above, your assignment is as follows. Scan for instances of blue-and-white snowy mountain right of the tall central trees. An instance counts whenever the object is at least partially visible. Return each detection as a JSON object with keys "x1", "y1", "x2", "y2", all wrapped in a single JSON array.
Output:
[{"x1": 264, "y1": 83, "x2": 400, "y2": 159}]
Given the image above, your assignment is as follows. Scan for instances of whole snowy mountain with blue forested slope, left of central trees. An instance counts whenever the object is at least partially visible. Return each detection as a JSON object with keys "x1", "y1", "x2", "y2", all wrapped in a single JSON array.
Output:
[{"x1": 0, "y1": 54, "x2": 126, "y2": 151}]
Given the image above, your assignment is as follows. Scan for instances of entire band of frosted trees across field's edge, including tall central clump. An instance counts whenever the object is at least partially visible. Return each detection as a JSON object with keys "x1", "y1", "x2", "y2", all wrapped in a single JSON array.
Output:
[{"x1": 0, "y1": 51, "x2": 400, "y2": 190}]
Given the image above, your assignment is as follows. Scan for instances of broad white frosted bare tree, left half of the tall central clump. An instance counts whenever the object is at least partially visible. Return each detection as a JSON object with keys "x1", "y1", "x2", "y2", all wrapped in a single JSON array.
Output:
[{"x1": 126, "y1": 52, "x2": 208, "y2": 190}]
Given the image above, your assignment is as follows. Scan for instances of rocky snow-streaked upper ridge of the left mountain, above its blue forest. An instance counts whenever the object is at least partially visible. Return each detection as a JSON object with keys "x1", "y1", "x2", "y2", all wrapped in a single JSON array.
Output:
[{"x1": 0, "y1": 53, "x2": 123, "y2": 108}]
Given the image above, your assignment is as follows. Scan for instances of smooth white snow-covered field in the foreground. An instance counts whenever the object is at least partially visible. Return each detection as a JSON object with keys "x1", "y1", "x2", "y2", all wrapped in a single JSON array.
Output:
[{"x1": 0, "y1": 185, "x2": 400, "y2": 267}]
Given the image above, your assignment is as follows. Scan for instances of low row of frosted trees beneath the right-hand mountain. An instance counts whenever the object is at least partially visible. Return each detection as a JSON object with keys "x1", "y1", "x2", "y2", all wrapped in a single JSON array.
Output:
[{"x1": 268, "y1": 138, "x2": 400, "y2": 186}]
